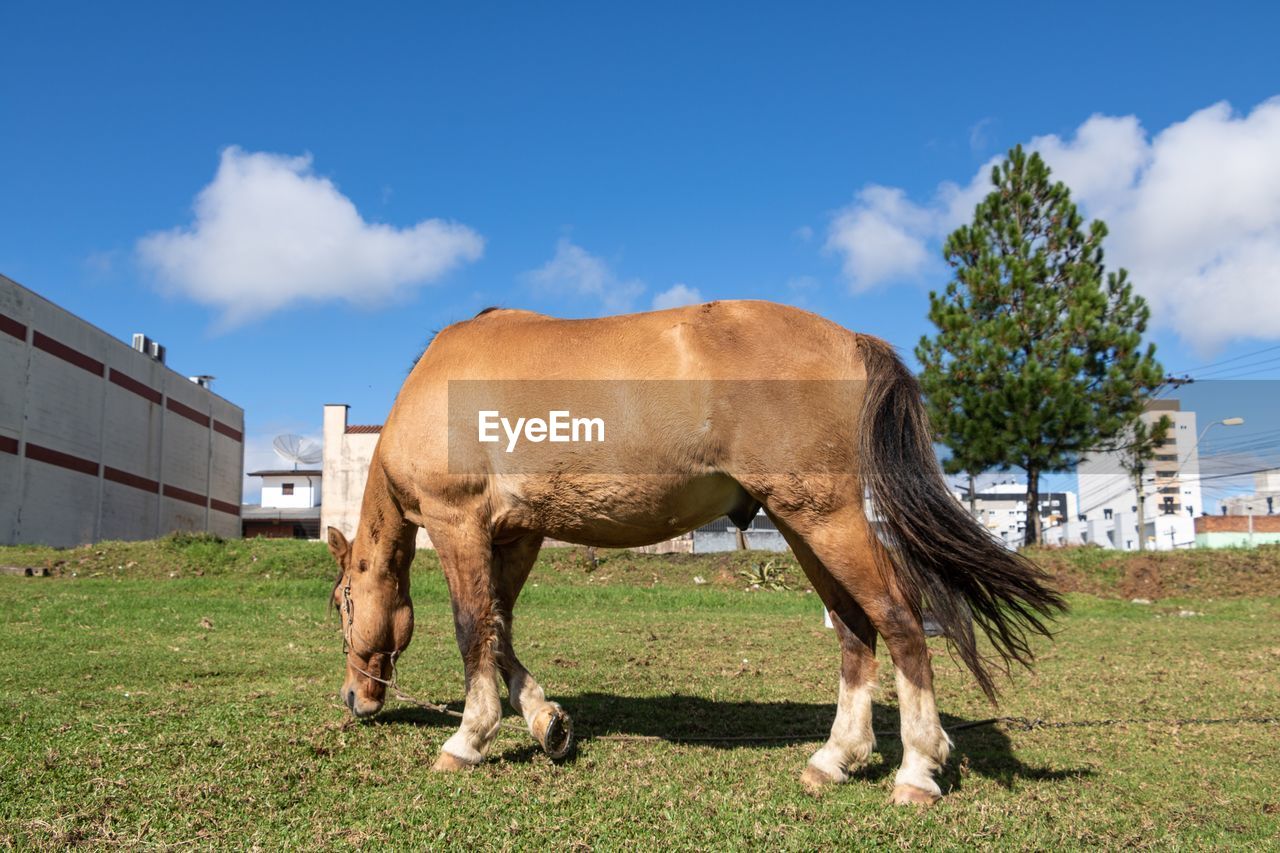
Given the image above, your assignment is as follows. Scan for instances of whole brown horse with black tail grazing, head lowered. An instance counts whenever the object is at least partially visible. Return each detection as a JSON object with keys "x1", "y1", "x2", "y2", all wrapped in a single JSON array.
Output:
[{"x1": 329, "y1": 301, "x2": 1062, "y2": 803}]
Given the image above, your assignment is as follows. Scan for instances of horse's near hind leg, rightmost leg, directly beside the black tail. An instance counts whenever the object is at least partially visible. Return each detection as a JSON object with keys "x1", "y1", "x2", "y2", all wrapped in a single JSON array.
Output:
[{"x1": 778, "y1": 506, "x2": 951, "y2": 804}]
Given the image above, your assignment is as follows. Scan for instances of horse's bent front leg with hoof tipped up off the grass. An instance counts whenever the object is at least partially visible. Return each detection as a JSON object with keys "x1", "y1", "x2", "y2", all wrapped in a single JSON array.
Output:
[{"x1": 494, "y1": 537, "x2": 573, "y2": 758}]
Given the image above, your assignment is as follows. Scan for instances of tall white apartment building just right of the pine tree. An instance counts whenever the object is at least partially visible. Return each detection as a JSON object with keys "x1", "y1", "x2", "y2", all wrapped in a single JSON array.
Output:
[{"x1": 1076, "y1": 400, "x2": 1204, "y2": 551}]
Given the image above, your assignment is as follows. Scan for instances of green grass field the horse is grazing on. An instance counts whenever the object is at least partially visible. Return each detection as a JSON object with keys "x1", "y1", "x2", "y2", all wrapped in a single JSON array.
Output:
[{"x1": 0, "y1": 538, "x2": 1280, "y2": 849}]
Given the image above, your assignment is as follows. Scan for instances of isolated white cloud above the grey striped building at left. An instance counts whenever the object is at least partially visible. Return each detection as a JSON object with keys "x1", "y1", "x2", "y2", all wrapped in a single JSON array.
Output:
[{"x1": 137, "y1": 147, "x2": 484, "y2": 327}]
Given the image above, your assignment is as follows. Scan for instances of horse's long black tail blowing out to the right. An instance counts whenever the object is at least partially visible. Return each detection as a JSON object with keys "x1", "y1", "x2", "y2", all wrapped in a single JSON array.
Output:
[{"x1": 860, "y1": 336, "x2": 1066, "y2": 701}]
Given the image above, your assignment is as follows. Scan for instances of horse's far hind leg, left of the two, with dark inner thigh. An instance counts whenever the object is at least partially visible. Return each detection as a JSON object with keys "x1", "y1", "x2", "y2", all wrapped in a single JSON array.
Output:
[{"x1": 776, "y1": 520, "x2": 876, "y2": 790}]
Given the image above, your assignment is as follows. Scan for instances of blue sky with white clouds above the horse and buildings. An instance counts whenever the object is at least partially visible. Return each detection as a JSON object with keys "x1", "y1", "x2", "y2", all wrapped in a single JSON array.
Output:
[{"x1": 0, "y1": 3, "x2": 1280, "y2": 502}]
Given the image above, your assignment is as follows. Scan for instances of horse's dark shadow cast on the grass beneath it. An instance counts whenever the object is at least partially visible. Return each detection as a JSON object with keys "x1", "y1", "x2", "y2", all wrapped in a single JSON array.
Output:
[{"x1": 376, "y1": 693, "x2": 1093, "y2": 790}]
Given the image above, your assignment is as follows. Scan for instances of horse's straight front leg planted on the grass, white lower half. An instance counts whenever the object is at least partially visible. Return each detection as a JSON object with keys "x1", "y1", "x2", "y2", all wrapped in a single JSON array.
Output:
[{"x1": 433, "y1": 532, "x2": 504, "y2": 770}]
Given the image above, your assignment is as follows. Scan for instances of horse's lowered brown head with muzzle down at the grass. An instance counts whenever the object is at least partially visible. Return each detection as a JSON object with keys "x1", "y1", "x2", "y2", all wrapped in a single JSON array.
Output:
[{"x1": 329, "y1": 528, "x2": 413, "y2": 717}]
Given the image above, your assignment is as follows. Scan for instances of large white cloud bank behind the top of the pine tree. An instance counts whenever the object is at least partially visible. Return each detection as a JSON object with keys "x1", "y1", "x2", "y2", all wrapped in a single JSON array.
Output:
[{"x1": 827, "y1": 97, "x2": 1280, "y2": 352}]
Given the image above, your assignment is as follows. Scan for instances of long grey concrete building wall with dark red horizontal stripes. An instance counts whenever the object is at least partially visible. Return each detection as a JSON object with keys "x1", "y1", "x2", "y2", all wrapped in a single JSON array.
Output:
[{"x1": 0, "y1": 275, "x2": 244, "y2": 546}]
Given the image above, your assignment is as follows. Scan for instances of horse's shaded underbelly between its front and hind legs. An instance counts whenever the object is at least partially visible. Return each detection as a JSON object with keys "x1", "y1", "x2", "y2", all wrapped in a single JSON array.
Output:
[{"x1": 497, "y1": 474, "x2": 750, "y2": 548}]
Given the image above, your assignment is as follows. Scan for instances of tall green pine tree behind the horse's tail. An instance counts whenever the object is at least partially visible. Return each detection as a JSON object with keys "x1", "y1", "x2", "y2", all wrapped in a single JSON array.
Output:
[{"x1": 915, "y1": 146, "x2": 1164, "y2": 546}]
